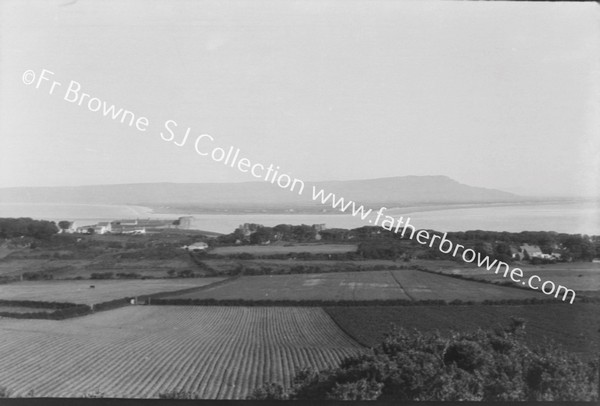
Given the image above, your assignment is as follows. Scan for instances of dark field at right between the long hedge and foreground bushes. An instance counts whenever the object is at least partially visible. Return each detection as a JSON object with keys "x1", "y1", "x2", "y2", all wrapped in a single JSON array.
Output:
[{"x1": 325, "y1": 303, "x2": 600, "y2": 359}]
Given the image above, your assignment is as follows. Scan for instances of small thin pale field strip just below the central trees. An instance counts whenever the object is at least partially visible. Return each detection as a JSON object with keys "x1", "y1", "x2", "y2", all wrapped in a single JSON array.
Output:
[{"x1": 210, "y1": 244, "x2": 358, "y2": 255}]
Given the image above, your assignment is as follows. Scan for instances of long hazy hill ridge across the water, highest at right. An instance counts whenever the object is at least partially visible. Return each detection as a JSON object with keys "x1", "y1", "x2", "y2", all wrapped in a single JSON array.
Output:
[{"x1": 0, "y1": 176, "x2": 520, "y2": 208}]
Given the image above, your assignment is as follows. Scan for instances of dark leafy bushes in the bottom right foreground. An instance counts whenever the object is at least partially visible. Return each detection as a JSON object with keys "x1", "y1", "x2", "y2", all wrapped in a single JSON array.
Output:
[{"x1": 251, "y1": 319, "x2": 599, "y2": 401}]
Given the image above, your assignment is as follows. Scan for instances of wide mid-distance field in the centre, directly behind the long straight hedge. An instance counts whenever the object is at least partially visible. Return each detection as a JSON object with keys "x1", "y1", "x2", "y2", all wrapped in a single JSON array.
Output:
[{"x1": 165, "y1": 270, "x2": 544, "y2": 301}]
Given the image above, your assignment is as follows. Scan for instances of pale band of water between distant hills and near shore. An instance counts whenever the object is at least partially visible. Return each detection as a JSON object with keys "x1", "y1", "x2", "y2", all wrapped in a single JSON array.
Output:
[{"x1": 0, "y1": 200, "x2": 600, "y2": 235}]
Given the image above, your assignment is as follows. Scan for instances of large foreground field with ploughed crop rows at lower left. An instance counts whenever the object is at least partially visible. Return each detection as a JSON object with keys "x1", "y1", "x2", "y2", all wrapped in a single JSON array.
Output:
[{"x1": 0, "y1": 306, "x2": 361, "y2": 399}]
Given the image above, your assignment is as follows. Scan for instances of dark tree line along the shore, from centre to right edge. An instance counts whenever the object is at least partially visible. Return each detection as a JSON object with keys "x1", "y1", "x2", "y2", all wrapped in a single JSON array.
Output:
[{"x1": 217, "y1": 224, "x2": 600, "y2": 263}]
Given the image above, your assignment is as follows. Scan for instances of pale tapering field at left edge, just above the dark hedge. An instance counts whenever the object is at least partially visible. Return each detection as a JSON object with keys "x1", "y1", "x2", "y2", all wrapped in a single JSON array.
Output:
[{"x1": 0, "y1": 278, "x2": 225, "y2": 304}]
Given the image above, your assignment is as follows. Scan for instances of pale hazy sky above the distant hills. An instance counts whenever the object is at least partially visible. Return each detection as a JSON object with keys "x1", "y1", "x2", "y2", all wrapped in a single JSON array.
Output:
[{"x1": 0, "y1": 0, "x2": 600, "y2": 195}]
